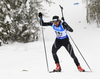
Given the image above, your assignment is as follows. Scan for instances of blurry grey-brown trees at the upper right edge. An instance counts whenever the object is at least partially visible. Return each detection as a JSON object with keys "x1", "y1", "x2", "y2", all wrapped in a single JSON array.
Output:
[{"x1": 83, "y1": 0, "x2": 100, "y2": 27}]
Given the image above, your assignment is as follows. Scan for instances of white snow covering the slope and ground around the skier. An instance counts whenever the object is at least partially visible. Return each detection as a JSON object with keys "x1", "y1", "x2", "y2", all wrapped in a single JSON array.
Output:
[{"x1": 0, "y1": 0, "x2": 100, "y2": 79}]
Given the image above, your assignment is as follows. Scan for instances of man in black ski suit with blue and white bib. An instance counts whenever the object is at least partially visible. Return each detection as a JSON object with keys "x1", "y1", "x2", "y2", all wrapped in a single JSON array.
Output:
[{"x1": 39, "y1": 12, "x2": 85, "y2": 72}]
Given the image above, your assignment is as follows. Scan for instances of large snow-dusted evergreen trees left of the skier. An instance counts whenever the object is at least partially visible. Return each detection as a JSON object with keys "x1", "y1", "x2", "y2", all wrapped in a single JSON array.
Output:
[{"x1": 0, "y1": 0, "x2": 52, "y2": 43}]
